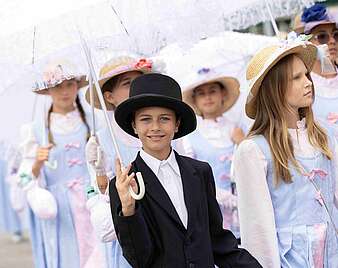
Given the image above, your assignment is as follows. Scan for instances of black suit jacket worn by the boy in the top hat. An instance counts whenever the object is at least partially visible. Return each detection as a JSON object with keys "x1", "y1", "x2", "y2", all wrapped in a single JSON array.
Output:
[{"x1": 109, "y1": 153, "x2": 261, "y2": 268}]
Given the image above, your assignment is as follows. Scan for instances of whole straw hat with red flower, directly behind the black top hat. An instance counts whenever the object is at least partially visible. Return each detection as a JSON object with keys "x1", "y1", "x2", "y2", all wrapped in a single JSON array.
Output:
[{"x1": 86, "y1": 56, "x2": 152, "y2": 110}]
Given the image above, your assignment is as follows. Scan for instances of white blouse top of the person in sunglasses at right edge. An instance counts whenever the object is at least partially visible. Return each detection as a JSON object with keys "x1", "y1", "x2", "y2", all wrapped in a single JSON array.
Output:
[{"x1": 311, "y1": 72, "x2": 338, "y2": 98}]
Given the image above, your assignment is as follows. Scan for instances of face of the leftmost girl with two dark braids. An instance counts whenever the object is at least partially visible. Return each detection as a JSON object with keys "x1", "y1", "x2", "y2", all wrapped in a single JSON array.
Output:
[{"x1": 48, "y1": 79, "x2": 78, "y2": 110}]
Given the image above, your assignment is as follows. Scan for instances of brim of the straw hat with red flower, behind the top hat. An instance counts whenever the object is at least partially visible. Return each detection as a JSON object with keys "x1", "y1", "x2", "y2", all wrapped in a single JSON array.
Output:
[{"x1": 86, "y1": 67, "x2": 150, "y2": 111}]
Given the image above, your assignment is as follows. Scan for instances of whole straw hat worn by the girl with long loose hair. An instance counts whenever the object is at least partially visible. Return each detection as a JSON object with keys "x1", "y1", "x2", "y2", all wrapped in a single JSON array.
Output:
[{"x1": 245, "y1": 40, "x2": 317, "y2": 119}]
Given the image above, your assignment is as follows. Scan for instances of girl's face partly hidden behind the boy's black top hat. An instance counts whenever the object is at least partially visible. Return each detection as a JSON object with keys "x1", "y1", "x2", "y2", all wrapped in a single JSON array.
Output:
[{"x1": 104, "y1": 71, "x2": 142, "y2": 107}]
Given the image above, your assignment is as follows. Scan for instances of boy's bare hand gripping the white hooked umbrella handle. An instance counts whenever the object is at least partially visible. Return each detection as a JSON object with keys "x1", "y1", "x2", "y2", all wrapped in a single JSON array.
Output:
[{"x1": 115, "y1": 159, "x2": 138, "y2": 216}]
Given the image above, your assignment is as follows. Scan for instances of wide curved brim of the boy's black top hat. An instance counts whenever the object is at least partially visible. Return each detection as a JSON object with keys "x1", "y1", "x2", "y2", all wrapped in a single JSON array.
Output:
[{"x1": 114, "y1": 94, "x2": 196, "y2": 139}]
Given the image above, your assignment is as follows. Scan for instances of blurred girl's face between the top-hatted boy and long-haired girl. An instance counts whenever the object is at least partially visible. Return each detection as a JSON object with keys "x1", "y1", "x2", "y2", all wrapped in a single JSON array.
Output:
[{"x1": 194, "y1": 83, "x2": 225, "y2": 118}]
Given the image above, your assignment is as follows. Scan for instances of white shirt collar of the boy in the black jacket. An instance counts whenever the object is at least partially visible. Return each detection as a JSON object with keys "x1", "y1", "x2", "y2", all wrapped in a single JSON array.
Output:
[{"x1": 140, "y1": 149, "x2": 181, "y2": 176}]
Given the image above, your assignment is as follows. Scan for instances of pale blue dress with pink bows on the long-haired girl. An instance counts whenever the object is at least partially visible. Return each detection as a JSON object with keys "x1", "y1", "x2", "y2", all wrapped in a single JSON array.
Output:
[{"x1": 253, "y1": 133, "x2": 338, "y2": 268}]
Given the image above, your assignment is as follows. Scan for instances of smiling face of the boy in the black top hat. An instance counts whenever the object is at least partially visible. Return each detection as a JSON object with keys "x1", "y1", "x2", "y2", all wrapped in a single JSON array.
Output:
[{"x1": 133, "y1": 107, "x2": 180, "y2": 156}]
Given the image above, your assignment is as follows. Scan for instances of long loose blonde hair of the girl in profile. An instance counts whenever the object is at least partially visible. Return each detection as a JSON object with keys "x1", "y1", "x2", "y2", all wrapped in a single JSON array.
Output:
[{"x1": 248, "y1": 55, "x2": 332, "y2": 184}]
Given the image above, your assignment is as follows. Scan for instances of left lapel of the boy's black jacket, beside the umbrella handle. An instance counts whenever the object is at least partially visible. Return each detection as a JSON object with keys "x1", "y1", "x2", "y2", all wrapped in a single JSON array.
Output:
[{"x1": 133, "y1": 153, "x2": 184, "y2": 229}]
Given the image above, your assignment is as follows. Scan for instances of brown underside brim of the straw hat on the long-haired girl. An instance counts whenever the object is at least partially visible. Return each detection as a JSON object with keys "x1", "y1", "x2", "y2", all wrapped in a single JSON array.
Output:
[{"x1": 245, "y1": 44, "x2": 317, "y2": 119}]
